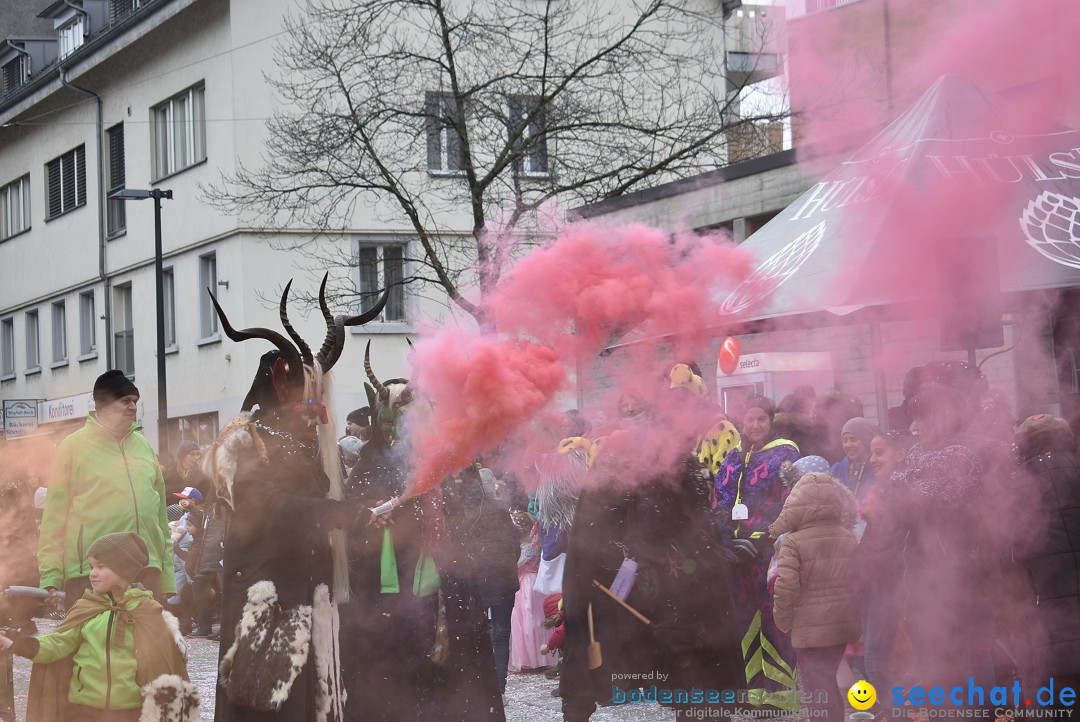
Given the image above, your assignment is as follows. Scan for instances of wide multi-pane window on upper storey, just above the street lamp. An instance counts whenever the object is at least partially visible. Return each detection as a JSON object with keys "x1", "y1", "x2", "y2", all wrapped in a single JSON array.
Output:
[{"x1": 152, "y1": 85, "x2": 206, "y2": 178}]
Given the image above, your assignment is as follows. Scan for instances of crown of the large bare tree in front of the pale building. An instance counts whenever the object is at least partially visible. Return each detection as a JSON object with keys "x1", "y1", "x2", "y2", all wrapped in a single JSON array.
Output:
[{"x1": 205, "y1": 0, "x2": 780, "y2": 321}]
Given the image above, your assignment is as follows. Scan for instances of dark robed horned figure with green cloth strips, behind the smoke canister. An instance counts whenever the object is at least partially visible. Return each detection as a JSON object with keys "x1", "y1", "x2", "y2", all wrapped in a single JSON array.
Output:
[{"x1": 341, "y1": 344, "x2": 503, "y2": 722}]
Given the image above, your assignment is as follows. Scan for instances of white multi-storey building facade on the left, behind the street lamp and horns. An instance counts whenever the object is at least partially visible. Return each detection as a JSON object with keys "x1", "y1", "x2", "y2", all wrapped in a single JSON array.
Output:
[{"x1": 0, "y1": 0, "x2": 779, "y2": 447}]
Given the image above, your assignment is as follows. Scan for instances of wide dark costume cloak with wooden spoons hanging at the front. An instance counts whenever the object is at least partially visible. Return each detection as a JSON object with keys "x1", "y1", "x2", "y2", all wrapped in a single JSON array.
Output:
[{"x1": 559, "y1": 371, "x2": 745, "y2": 722}]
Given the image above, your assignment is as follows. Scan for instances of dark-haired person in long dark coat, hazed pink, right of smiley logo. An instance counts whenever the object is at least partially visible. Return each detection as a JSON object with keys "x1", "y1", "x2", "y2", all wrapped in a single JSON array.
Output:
[{"x1": 882, "y1": 385, "x2": 993, "y2": 689}]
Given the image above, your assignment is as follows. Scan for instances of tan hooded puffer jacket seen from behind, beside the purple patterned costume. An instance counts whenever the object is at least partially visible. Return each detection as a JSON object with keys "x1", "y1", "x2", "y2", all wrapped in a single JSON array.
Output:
[{"x1": 769, "y1": 474, "x2": 861, "y2": 649}]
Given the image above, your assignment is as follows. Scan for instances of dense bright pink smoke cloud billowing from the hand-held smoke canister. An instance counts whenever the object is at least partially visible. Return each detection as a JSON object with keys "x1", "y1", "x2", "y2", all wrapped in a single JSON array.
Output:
[{"x1": 409, "y1": 223, "x2": 753, "y2": 493}]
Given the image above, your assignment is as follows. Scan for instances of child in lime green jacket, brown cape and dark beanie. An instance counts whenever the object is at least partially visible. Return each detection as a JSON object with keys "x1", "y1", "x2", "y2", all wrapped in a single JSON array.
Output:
[{"x1": 0, "y1": 532, "x2": 199, "y2": 722}]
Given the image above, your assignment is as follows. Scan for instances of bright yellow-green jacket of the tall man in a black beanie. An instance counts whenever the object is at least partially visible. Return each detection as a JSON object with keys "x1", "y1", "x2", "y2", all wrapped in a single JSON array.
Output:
[{"x1": 38, "y1": 416, "x2": 176, "y2": 594}]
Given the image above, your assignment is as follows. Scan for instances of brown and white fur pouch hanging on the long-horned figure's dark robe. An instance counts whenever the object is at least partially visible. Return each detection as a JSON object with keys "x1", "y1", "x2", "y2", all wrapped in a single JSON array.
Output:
[{"x1": 218, "y1": 582, "x2": 311, "y2": 712}]
